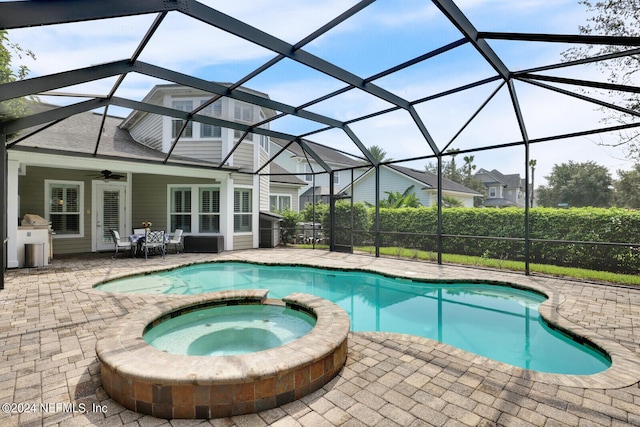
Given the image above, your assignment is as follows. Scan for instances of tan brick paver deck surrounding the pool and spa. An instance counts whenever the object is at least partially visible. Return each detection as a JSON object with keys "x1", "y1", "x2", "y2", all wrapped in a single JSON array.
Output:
[{"x1": 0, "y1": 249, "x2": 640, "y2": 427}]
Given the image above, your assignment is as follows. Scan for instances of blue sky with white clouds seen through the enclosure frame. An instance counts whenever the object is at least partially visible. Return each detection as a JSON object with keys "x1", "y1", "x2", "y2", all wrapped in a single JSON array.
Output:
[{"x1": 9, "y1": 0, "x2": 631, "y2": 182}]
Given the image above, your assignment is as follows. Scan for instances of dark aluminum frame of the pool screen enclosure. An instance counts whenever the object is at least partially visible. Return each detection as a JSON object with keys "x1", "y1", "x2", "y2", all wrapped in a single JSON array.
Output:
[{"x1": 0, "y1": 0, "x2": 640, "y2": 287}]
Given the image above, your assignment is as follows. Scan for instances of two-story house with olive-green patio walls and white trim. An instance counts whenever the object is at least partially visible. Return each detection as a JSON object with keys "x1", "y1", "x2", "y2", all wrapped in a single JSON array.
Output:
[{"x1": 7, "y1": 84, "x2": 284, "y2": 267}]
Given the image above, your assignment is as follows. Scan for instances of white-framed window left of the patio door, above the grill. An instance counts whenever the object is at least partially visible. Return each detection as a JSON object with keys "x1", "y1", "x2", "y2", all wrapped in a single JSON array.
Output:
[{"x1": 45, "y1": 180, "x2": 84, "y2": 237}]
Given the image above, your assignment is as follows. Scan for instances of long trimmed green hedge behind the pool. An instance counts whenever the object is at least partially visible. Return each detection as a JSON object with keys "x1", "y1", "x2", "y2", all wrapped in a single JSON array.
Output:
[{"x1": 314, "y1": 203, "x2": 640, "y2": 274}]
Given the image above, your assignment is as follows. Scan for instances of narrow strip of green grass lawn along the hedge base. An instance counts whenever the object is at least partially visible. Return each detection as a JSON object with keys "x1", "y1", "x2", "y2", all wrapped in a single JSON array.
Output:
[{"x1": 296, "y1": 245, "x2": 640, "y2": 285}]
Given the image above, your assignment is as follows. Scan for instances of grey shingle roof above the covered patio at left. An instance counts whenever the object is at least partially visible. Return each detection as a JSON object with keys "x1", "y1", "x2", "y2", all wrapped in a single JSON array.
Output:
[{"x1": 8, "y1": 103, "x2": 233, "y2": 169}]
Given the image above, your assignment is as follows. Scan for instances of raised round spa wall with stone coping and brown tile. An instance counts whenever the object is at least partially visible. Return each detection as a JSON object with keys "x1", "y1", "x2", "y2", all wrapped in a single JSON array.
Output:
[{"x1": 96, "y1": 290, "x2": 350, "y2": 419}]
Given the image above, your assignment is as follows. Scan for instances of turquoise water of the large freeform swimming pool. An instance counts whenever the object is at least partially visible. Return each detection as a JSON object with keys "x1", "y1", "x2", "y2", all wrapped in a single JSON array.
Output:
[{"x1": 98, "y1": 262, "x2": 611, "y2": 375}]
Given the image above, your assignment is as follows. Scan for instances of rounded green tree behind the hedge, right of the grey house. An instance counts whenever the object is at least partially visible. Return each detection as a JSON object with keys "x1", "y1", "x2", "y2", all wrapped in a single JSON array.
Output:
[{"x1": 537, "y1": 161, "x2": 614, "y2": 207}]
